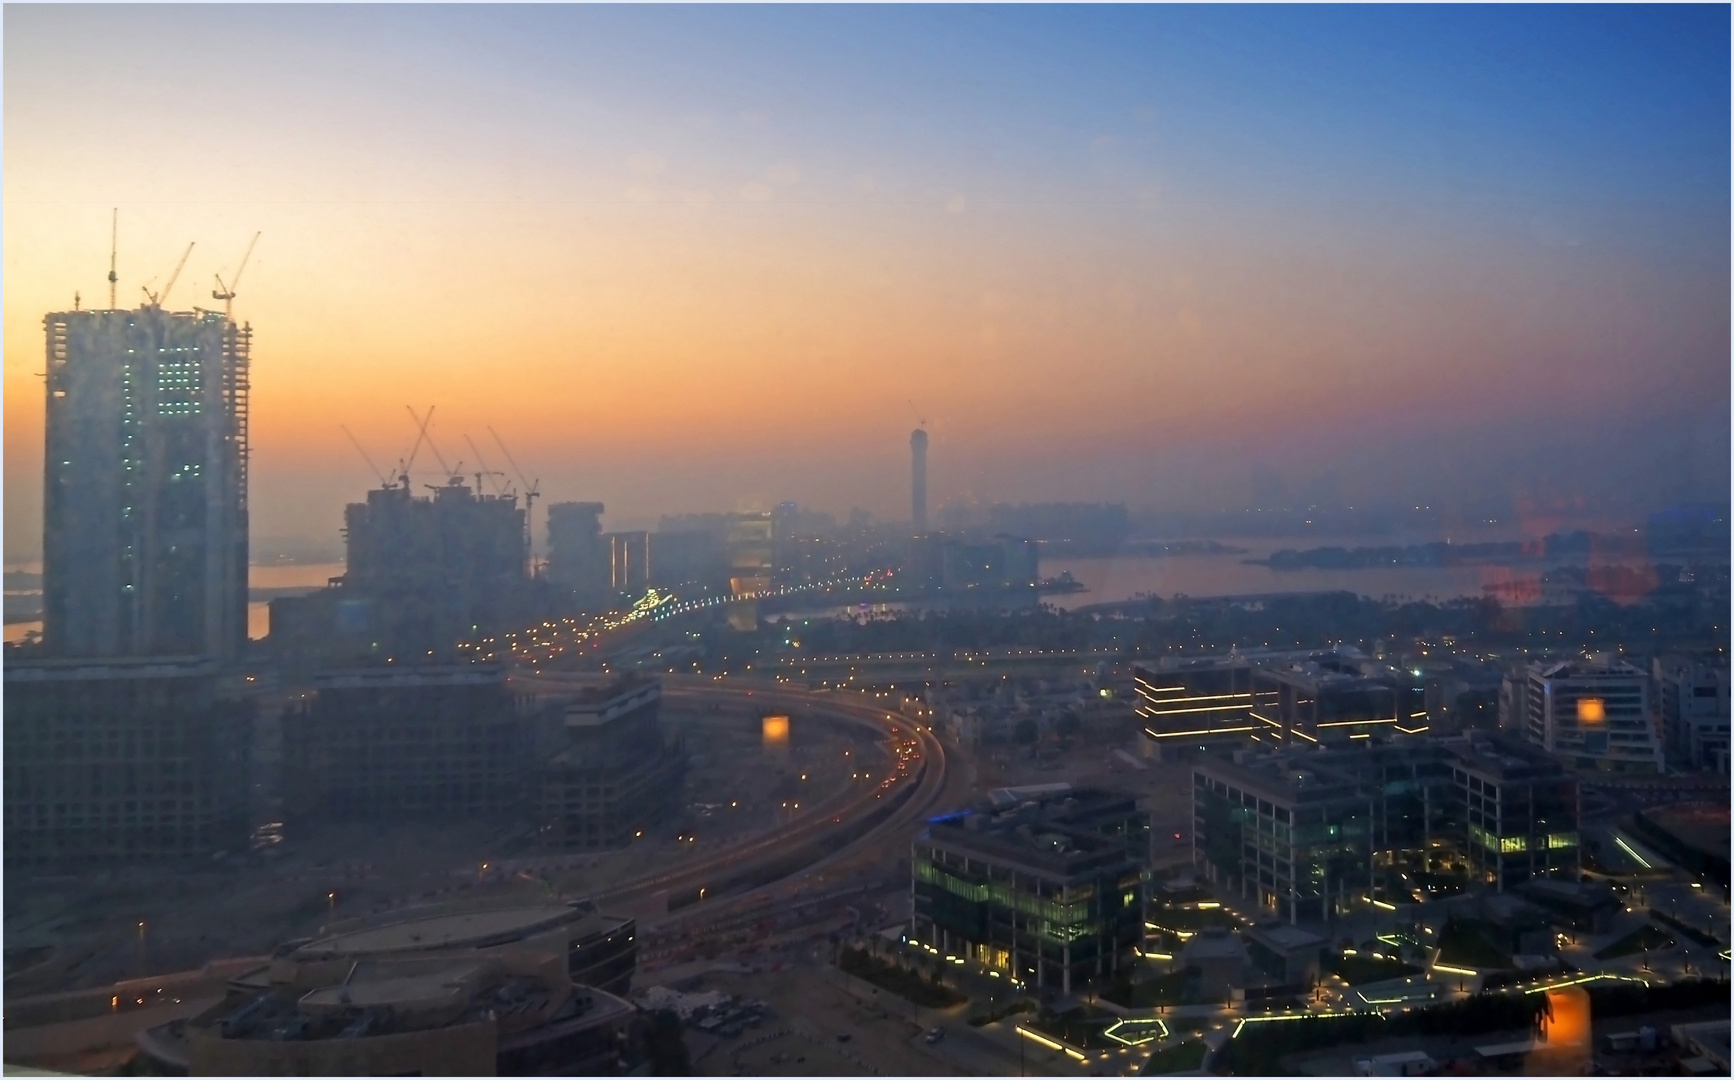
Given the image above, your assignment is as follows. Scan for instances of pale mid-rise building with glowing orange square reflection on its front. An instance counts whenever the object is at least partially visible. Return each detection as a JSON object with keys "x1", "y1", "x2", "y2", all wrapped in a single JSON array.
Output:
[{"x1": 1524, "y1": 659, "x2": 1663, "y2": 773}]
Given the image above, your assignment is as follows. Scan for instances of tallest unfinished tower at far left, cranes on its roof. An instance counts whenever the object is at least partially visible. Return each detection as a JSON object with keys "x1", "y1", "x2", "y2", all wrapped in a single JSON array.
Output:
[{"x1": 42, "y1": 303, "x2": 251, "y2": 659}]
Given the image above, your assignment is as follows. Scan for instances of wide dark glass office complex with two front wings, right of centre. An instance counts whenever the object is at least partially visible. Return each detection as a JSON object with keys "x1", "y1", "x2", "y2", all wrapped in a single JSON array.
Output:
[{"x1": 1193, "y1": 738, "x2": 1578, "y2": 922}]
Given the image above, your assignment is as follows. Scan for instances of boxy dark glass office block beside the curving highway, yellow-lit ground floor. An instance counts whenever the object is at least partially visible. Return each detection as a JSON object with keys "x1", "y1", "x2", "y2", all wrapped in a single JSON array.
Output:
[{"x1": 910, "y1": 785, "x2": 1150, "y2": 993}]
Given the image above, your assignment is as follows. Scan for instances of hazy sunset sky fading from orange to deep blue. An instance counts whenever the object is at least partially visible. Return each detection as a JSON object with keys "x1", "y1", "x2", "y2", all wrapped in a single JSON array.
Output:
[{"x1": 3, "y1": 5, "x2": 1731, "y2": 560}]
